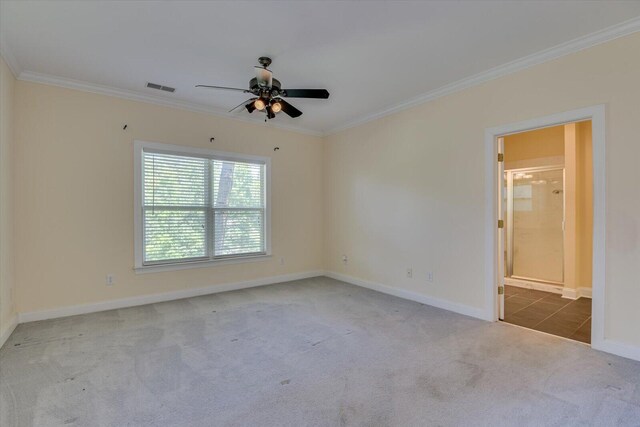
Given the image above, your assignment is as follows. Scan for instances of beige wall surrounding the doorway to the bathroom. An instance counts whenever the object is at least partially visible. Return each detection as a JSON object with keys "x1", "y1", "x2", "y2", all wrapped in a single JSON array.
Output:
[{"x1": 325, "y1": 33, "x2": 640, "y2": 345}]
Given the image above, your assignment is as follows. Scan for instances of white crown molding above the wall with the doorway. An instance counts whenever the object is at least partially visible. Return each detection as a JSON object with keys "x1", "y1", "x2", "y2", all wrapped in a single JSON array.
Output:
[{"x1": 324, "y1": 17, "x2": 640, "y2": 136}]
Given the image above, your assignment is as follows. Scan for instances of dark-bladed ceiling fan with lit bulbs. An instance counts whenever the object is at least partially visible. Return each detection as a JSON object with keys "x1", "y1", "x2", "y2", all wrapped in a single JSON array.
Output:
[{"x1": 196, "y1": 56, "x2": 329, "y2": 122}]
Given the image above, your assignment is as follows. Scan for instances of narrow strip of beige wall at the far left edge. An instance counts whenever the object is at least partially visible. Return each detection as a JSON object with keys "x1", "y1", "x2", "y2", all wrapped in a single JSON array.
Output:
[{"x1": 0, "y1": 58, "x2": 16, "y2": 338}]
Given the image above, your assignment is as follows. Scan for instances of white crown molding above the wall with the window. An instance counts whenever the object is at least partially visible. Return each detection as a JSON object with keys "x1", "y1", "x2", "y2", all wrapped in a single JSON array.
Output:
[{"x1": 18, "y1": 71, "x2": 323, "y2": 136}]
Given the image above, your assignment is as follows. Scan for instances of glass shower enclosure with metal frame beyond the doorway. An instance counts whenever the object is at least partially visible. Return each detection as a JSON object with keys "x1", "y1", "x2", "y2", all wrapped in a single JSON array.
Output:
[{"x1": 503, "y1": 166, "x2": 565, "y2": 285}]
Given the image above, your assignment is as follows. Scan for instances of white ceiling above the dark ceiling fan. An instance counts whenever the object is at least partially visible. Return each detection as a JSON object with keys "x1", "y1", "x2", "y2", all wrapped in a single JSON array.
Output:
[{"x1": 0, "y1": 0, "x2": 640, "y2": 132}]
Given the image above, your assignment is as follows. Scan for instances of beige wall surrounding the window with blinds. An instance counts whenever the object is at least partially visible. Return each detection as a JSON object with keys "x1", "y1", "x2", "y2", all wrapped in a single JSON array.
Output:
[{"x1": 15, "y1": 81, "x2": 323, "y2": 312}]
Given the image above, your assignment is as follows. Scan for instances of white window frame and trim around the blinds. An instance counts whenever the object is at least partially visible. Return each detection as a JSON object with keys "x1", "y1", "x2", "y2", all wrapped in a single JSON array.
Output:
[{"x1": 133, "y1": 140, "x2": 271, "y2": 273}]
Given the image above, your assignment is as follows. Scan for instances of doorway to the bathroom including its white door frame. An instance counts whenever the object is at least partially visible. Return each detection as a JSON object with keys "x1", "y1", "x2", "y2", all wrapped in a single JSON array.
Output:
[{"x1": 486, "y1": 106, "x2": 604, "y2": 348}]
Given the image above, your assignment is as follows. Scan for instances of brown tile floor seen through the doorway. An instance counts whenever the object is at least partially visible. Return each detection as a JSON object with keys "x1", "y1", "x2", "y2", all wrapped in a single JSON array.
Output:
[{"x1": 504, "y1": 286, "x2": 591, "y2": 344}]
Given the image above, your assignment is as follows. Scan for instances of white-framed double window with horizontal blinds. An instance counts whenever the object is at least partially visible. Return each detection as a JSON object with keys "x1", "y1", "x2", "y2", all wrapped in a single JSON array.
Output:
[{"x1": 136, "y1": 142, "x2": 269, "y2": 268}]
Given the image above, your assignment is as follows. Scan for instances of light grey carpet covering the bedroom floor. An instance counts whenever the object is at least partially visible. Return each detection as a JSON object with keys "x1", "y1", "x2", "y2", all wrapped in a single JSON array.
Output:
[{"x1": 0, "y1": 277, "x2": 640, "y2": 427}]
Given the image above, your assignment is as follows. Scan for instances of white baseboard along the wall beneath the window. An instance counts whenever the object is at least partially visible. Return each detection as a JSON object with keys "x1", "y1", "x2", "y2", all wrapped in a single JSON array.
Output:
[{"x1": 18, "y1": 270, "x2": 324, "y2": 323}]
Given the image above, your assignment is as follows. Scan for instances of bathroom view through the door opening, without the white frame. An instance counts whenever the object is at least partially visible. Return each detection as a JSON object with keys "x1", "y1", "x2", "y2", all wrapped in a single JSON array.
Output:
[{"x1": 499, "y1": 120, "x2": 593, "y2": 344}]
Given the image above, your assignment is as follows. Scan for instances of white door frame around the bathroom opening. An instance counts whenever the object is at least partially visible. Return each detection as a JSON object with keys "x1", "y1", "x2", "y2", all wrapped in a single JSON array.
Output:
[{"x1": 485, "y1": 105, "x2": 610, "y2": 351}]
